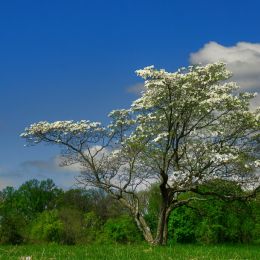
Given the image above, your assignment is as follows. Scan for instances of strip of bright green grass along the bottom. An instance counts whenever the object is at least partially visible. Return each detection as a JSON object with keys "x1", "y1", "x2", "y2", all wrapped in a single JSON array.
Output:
[{"x1": 0, "y1": 245, "x2": 260, "y2": 260}]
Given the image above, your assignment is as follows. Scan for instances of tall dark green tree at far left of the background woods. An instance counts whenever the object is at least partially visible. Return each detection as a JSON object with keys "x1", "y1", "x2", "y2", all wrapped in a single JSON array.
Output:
[{"x1": 0, "y1": 179, "x2": 62, "y2": 244}]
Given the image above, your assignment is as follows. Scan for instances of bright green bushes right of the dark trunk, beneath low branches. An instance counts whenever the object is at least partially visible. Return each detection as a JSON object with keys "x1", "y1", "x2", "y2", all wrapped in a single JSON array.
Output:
[{"x1": 168, "y1": 195, "x2": 255, "y2": 244}]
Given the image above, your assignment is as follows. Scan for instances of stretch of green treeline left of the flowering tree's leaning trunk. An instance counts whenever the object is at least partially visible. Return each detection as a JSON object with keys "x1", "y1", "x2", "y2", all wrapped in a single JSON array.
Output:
[{"x1": 0, "y1": 179, "x2": 141, "y2": 244}]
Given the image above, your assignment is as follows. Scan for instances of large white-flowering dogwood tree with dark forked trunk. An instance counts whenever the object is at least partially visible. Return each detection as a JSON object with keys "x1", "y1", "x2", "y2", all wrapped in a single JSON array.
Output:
[{"x1": 21, "y1": 63, "x2": 260, "y2": 244}]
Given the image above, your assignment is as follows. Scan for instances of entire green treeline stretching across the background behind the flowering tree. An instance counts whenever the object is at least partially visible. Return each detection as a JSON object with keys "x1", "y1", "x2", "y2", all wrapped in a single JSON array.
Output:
[{"x1": 0, "y1": 179, "x2": 260, "y2": 245}]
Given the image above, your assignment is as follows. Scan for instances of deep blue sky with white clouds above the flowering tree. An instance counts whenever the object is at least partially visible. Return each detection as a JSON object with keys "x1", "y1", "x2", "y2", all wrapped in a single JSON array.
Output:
[{"x1": 0, "y1": 0, "x2": 260, "y2": 188}]
